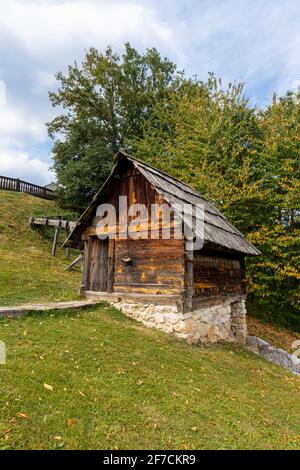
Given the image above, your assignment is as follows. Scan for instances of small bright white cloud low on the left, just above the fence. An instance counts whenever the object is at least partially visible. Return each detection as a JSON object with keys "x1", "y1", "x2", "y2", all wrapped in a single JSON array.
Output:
[{"x1": 0, "y1": 147, "x2": 54, "y2": 186}]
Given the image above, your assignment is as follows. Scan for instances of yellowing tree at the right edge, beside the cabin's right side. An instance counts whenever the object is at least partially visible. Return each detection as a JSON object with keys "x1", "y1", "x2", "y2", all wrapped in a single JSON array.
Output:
[{"x1": 249, "y1": 93, "x2": 300, "y2": 331}]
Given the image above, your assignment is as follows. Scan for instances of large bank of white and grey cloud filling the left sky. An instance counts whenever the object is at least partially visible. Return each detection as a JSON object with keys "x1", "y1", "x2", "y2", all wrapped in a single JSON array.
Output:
[{"x1": 0, "y1": 0, "x2": 177, "y2": 181}]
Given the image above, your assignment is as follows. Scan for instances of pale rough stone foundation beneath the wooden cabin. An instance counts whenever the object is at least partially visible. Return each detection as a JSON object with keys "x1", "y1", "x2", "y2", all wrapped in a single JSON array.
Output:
[{"x1": 87, "y1": 293, "x2": 247, "y2": 344}]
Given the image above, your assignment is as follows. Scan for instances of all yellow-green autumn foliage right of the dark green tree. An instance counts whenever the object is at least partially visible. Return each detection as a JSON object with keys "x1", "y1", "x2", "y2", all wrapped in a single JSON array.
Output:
[{"x1": 134, "y1": 75, "x2": 300, "y2": 330}]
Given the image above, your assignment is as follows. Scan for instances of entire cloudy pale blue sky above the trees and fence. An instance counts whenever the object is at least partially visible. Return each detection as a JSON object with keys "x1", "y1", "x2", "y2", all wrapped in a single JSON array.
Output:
[{"x1": 0, "y1": 0, "x2": 300, "y2": 185}]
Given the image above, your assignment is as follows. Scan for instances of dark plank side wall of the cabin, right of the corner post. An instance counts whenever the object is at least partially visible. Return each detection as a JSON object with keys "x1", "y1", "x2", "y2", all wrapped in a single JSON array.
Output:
[{"x1": 193, "y1": 248, "x2": 246, "y2": 299}]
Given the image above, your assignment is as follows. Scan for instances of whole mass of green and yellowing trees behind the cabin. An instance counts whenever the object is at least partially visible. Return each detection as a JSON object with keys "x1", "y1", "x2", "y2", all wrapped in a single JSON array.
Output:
[{"x1": 48, "y1": 43, "x2": 300, "y2": 330}]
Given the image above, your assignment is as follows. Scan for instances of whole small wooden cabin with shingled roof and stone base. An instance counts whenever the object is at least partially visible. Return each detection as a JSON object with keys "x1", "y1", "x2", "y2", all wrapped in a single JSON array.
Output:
[{"x1": 64, "y1": 151, "x2": 260, "y2": 343}]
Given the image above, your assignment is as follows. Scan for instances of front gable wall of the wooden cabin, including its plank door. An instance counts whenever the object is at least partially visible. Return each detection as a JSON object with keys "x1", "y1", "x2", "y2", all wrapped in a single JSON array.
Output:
[{"x1": 83, "y1": 165, "x2": 184, "y2": 295}]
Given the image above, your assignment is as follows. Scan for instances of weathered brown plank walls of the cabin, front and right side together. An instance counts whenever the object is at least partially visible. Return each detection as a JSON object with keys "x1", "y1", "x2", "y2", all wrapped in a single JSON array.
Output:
[{"x1": 76, "y1": 162, "x2": 245, "y2": 302}]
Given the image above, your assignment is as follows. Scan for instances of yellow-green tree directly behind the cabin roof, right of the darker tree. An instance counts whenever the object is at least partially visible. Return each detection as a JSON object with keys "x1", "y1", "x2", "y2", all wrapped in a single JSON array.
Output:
[{"x1": 134, "y1": 74, "x2": 264, "y2": 232}]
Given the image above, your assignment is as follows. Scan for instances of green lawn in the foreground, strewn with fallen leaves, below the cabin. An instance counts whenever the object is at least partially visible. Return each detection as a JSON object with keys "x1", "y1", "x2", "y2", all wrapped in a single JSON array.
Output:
[{"x1": 0, "y1": 304, "x2": 300, "y2": 449}]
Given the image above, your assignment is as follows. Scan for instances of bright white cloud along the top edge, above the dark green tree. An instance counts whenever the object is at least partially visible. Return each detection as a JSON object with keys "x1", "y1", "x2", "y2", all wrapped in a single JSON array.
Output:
[{"x1": 0, "y1": 0, "x2": 176, "y2": 62}]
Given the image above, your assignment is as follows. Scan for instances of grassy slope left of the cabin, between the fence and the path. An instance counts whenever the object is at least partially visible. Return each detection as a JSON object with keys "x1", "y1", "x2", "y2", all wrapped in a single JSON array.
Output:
[{"x1": 0, "y1": 190, "x2": 80, "y2": 306}]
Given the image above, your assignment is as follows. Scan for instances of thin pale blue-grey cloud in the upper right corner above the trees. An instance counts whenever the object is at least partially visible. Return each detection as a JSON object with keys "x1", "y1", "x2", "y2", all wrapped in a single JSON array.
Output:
[{"x1": 171, "y1": 0, "x2": 300, "y2": 99}]
